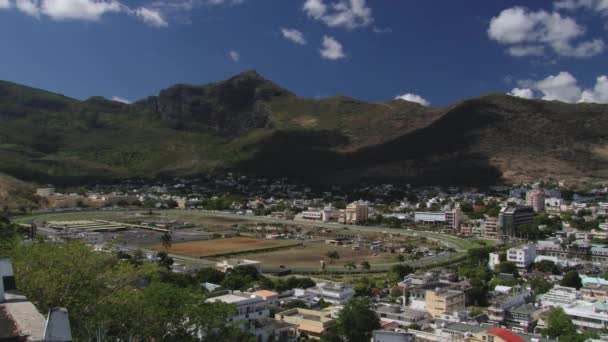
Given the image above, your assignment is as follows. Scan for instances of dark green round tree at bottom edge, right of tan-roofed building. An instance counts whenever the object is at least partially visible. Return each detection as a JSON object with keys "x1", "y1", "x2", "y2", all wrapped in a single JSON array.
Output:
[{"x1": 336, "y1": 298, "x2": 380, "y2": 342}]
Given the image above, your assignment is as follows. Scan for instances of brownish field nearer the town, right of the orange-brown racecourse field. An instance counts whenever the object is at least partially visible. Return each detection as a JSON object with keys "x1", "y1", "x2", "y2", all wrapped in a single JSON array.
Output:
[{"x1": 243, "y1": 241, "x2": 397, "y2": 267}]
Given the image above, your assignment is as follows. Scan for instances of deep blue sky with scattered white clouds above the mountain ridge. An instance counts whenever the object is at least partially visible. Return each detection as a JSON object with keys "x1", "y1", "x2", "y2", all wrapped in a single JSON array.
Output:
[{"x1": 0, "y1": 0, "x2": 608, "y2": 106}]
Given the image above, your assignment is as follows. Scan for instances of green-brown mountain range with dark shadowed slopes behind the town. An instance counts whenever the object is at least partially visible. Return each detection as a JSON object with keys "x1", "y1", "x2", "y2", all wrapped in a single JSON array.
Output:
[{"x1": 0, "y1": 71, "x2": 608, "y2": 185}]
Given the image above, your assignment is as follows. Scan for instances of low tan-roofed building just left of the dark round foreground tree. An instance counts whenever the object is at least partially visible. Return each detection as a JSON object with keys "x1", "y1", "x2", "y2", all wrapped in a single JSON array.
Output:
[{"x1": 274, "y1": 308, "x2": 336, "y2": 339}]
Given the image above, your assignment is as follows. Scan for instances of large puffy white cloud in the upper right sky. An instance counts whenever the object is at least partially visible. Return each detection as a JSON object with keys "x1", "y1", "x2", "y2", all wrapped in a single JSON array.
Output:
[{"x1": 487, "y1": 7, "x2": 604, "y2": 58}]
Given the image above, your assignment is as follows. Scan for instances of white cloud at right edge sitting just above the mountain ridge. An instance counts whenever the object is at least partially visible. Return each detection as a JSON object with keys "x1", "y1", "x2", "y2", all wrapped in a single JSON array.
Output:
[{"x1": 509, "y1": 71, "x2": 608, "y2": 103}]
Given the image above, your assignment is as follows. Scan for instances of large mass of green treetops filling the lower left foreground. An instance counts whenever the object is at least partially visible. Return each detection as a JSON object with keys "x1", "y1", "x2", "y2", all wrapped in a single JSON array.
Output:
[{"x1": 10, "y1": 243, "x2": 240, "y2": 341}]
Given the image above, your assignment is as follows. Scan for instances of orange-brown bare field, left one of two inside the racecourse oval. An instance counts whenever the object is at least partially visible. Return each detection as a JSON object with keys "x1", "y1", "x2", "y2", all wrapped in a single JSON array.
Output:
[{"x1": 148, "y1": 237, "x2": 301, "y2": 257}]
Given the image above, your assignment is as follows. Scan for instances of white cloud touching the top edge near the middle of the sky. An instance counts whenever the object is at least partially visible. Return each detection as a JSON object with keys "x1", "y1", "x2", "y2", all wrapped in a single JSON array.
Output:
[{"x1": 302, "y1": 0, "x2": 374, "y2": 30}]
